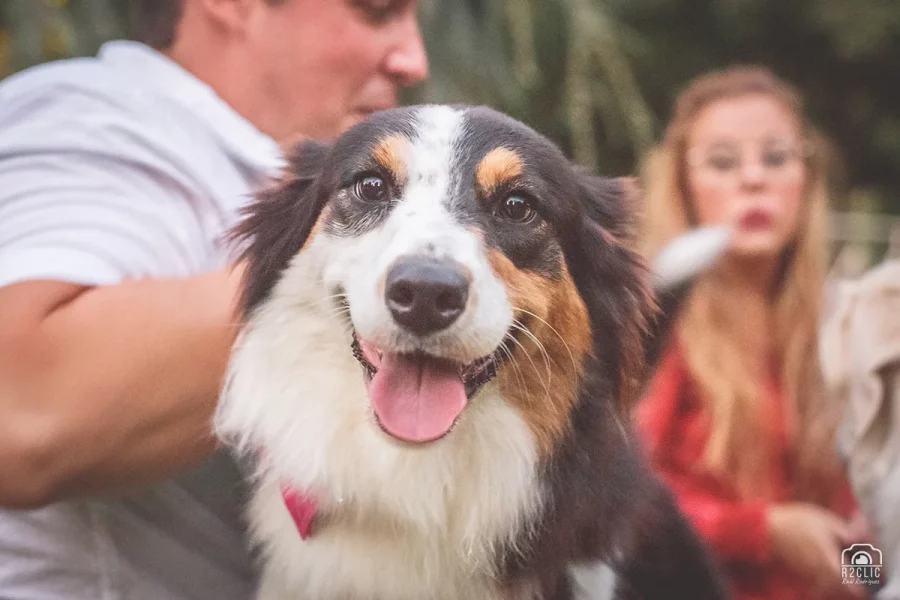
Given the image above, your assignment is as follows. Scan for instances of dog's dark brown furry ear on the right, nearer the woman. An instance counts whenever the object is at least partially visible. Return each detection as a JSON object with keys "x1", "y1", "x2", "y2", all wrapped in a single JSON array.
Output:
[{"x1": 570, "y1": 173, "x2": 655, "y2": 416}]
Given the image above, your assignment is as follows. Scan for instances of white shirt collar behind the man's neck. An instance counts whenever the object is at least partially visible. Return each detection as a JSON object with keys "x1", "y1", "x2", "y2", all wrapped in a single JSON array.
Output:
[{"x1": 98, "y1": 40, "x2": 284, "y2": 177}]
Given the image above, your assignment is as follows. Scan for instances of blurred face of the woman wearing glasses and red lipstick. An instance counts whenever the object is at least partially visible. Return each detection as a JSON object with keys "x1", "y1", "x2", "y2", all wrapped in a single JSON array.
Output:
[{"x1": 687, "y1": 94, "x2": 806, "y2": 259}]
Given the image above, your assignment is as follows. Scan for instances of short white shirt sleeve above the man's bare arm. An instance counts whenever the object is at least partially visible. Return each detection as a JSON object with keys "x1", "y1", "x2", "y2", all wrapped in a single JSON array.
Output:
[{"x1": 0, "y1": 86, "x2": 208, "y2": 286}]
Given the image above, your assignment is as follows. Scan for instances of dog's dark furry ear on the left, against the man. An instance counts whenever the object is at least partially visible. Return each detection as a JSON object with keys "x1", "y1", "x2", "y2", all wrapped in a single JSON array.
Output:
[{"x1": 230, "y1": 141, "x2": 330, "y2": 318}]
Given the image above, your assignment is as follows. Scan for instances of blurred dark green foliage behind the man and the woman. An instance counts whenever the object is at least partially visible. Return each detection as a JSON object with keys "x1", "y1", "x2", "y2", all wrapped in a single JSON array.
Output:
[{"x1": 0, "y1": 0, "x2": 900, "y2": 272}]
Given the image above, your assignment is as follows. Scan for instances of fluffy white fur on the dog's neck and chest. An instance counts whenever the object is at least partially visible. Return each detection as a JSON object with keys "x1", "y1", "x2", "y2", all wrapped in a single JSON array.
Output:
[{"x1": 216, "y1": 247, "x2": 543, "y2": 600}]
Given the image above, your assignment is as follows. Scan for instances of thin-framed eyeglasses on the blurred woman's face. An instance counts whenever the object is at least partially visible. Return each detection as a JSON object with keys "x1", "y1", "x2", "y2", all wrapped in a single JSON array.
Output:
[{"x1": 687, "y1": 141, "x2": 812, "y2": 175}]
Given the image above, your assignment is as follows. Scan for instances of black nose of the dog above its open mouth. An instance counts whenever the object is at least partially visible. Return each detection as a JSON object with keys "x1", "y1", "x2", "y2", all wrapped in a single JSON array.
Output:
[{"x1": 384, "y1": 257, "x2": 469, "y2": 335}]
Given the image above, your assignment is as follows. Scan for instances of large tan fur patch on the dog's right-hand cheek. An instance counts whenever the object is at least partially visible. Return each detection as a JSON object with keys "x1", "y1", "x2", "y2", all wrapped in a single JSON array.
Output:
[{"x1": 489, "y1": 250, "x2": 591, "y2": 456}]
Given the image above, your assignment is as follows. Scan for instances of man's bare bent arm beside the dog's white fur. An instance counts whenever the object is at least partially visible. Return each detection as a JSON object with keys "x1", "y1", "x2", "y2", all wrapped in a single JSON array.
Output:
[{"x1": 0, "y1": 270, "x2": 239, "y2": 508}]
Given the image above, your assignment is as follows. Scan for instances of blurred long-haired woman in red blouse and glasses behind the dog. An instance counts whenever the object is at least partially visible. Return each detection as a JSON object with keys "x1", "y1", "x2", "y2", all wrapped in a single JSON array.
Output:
[{"x1": 637, "y1": 67, "x2": 864, "y2": 600}]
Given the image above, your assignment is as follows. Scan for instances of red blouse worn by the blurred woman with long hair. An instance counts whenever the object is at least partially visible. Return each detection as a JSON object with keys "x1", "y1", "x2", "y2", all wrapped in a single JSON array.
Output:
[{"x1": 637, "y1": 347, "x2": 854, "y2": 600}]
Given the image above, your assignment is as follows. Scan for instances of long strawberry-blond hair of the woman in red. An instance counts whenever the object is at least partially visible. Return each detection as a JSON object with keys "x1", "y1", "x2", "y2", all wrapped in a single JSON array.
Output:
[{"x1": 641, "y1": 67, "x2": 837, "y2": 503}]
